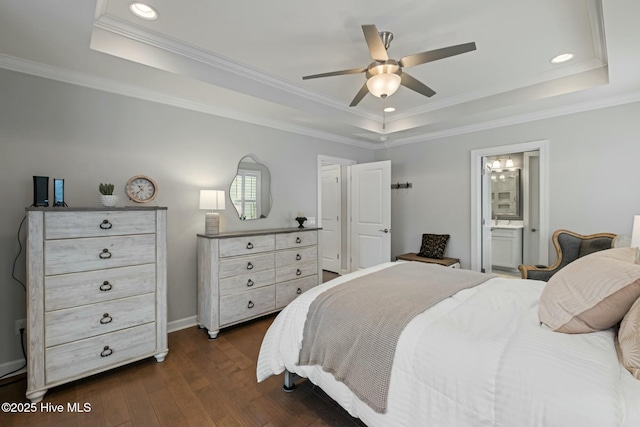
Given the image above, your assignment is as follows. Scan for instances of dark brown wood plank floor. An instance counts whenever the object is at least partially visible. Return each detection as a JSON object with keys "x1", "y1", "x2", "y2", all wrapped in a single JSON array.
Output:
[{"x1": 0, "y1": 310, "x2": 364, "y2": 427}]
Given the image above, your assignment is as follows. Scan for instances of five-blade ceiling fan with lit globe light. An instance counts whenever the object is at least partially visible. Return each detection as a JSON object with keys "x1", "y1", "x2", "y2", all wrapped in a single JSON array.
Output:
[{"x1": 302, "y1": 25, "x2": 476, "y2": 107}]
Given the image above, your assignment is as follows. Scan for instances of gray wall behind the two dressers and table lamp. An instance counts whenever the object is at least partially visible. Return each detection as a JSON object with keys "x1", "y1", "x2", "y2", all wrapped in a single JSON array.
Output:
[{"x1": 0, "y1": 70, "x2": 374, "y2": 375}]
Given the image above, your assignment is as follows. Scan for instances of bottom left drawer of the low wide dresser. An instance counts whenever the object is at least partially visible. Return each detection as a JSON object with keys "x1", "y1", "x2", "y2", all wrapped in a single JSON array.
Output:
[{"x1": 220, "y1": 286, "x2": 276, "y2": 326}]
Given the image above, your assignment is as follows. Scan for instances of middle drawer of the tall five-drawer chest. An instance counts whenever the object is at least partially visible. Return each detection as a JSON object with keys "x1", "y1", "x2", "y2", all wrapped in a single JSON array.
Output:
[{"x1": 44, "y1": 264, "x2": 156, "y2": 311}]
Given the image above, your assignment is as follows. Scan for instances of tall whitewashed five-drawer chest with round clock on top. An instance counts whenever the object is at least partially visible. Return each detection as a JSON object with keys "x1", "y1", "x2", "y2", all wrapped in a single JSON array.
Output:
[{"x1": 26, "y1": 207, "x2": 169, "y2": 402}]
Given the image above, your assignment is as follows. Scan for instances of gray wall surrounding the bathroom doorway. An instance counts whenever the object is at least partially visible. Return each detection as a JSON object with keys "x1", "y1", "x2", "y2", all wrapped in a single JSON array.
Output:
[{"x1": 376, "y1": 103, "x2": 640, "y2": 268}]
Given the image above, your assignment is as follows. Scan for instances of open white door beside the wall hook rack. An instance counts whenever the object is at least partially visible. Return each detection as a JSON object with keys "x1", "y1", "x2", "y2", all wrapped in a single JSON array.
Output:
[{"x1": 350, "y1": 160, "x2": 391, "y2": 271}]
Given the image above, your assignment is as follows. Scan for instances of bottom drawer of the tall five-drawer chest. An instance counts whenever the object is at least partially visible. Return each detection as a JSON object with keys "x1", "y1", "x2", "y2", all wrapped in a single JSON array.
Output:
[{"x1": 45, "y1": 323, "x2": 156, "y2": 383}]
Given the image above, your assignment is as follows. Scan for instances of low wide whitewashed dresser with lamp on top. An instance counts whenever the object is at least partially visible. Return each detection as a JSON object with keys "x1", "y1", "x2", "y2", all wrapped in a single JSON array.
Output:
[{"x1": 198, "y1": 228, "x2": 322, "y2": 339}]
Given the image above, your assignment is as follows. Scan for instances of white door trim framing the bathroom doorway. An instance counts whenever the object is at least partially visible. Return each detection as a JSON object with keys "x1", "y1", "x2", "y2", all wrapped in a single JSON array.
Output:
[{"x1": 471, "y1": 140, "x2": 549, "y2": 271}]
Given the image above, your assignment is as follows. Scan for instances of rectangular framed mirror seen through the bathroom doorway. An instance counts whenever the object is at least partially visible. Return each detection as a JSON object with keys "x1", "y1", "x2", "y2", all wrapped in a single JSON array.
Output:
[{"x1": 491, "y1": 169, "x2": 522, "y2": 219}]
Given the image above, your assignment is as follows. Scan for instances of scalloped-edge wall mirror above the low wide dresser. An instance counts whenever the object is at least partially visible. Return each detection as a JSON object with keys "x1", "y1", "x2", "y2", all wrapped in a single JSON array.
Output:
[{"x1": 229, "y1": 156, "x2": 271, "y2": 220}]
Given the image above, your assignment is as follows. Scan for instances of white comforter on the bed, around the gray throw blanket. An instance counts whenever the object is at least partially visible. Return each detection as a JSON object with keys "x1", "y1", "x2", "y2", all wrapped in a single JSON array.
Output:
[{"x1": 257, "y1": 262, "x2": 640, "y2": 427}]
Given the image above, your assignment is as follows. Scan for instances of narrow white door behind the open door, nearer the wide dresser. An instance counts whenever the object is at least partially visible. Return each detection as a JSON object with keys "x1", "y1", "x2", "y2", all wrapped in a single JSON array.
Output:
[{"x1": 321, "y1": 165, "x2": 342, "y2": 273}]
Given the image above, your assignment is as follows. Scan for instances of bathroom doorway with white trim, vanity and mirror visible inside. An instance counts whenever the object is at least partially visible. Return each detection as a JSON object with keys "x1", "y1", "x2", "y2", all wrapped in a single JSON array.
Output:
[{"x1": 471, "y1": 141, "x2": 549, "y2": 275}]
